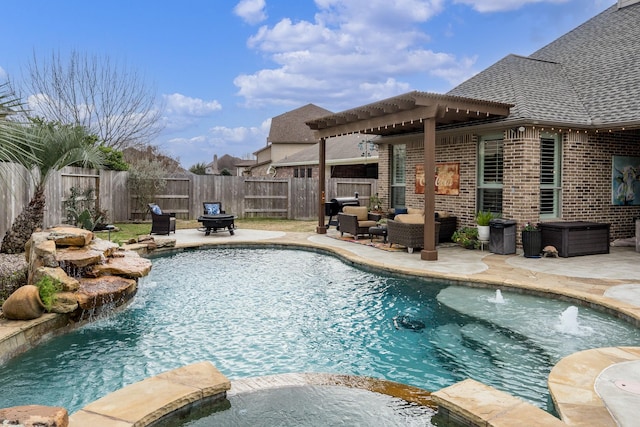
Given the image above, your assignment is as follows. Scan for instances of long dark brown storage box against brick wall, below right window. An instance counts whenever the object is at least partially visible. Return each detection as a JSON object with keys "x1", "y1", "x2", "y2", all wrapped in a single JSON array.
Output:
[{"x1": 538, "y1": 221, "x2": 610, "y2": 258}]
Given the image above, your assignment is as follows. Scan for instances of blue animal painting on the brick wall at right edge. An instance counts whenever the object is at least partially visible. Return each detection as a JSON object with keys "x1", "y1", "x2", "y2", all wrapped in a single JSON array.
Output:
[{"x1": 611, "y1": 156, "x2": 640, "y2": 206}]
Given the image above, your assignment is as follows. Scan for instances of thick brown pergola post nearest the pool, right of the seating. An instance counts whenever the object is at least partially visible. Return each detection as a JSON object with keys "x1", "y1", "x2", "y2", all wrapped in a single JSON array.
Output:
[{"x1": 420, "y1": 117, "x2": 438, "y2": 261}]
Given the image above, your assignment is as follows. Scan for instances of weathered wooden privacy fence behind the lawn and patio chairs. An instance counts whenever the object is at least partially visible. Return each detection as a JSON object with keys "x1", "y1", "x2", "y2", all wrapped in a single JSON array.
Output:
[{"x1": 0, "y1": 163, "x2": 378, "y2": 238}]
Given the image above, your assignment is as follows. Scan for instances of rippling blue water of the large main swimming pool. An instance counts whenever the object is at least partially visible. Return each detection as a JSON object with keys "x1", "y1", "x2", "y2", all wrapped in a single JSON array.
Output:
[{"x1": 0, "y1": 249, "x2": 640, "y2": 413}]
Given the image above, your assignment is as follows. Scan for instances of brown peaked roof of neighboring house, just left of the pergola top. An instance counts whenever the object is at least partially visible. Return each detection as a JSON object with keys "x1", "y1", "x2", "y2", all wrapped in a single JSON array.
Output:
[{"x1": 267, "y1": 104, "x2": 331, "y2": 144}]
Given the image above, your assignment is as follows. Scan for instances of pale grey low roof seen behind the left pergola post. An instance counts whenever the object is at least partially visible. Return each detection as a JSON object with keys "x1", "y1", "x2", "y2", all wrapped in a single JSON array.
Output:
[{"x1": 273, "y1": 134, "x2": 379, "y2": 167}]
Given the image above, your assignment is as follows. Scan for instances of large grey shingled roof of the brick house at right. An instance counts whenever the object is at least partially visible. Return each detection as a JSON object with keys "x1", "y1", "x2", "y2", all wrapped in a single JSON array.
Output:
[{"x1": 448, "y1": 3, "x2": 640, "y2": 126}]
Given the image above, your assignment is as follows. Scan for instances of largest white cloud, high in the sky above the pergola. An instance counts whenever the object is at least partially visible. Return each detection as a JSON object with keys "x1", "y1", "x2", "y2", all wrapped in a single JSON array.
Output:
[{"x1": 234, "y1": 0, "x2": 475, "y2": 108}]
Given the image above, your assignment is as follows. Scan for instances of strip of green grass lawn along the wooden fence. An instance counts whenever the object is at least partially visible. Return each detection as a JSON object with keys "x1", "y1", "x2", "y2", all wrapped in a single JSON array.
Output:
[{"x1": 104, "y1": 218, "x2": 318, "y2": 243}]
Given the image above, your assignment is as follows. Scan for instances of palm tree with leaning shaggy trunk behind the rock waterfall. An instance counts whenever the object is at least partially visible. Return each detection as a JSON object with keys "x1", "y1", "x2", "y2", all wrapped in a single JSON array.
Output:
[{"x1": 0, "y1": 119, "x2": 104, "y2": 253}]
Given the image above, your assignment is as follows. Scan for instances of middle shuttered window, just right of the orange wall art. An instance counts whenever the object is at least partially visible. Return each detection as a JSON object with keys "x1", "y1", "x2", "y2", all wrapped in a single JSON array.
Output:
[{"x1": 478, "y1": 136, "x2": 504, "y2": 215}]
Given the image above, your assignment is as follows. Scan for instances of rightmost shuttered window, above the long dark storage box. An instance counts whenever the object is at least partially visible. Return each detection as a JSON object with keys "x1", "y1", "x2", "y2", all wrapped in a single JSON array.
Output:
[{"x1": 540, "y1": 134, "x2": 562, "y2": 218}]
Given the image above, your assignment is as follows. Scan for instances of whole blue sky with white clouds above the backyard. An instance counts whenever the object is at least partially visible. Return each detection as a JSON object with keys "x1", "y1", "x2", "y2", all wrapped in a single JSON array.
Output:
[{"x1": 0, "y1": 0, "x2": 616, "y2": 168}]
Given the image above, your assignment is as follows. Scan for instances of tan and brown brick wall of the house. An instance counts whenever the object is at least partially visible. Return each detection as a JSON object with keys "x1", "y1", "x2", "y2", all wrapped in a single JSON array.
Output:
[{"x1": 378, "y1": 127, "x2": 640, "y2": 240}]
